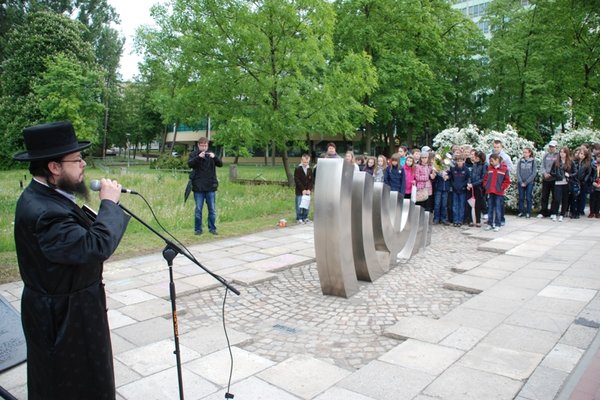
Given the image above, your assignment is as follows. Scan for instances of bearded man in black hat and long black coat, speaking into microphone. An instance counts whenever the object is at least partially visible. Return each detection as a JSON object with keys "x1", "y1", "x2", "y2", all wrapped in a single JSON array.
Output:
[{"x1": 14, "y1": 122, "x2": 129, "y2": 400}]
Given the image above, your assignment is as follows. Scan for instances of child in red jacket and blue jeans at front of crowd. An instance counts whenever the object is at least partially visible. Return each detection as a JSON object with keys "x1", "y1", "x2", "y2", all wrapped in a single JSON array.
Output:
[{"x1": 483, "y1": 154, "x2": 510, "y2": 232}]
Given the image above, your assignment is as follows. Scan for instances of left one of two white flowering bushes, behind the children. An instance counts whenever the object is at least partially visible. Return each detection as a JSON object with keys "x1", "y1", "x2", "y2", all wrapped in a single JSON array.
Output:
[{"x1": 433, "y1": 125, "x2": 543, "y2": 209}]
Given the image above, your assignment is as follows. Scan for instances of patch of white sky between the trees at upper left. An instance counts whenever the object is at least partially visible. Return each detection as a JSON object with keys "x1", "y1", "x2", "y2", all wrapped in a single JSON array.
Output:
[{"x1": 108, "y1": 0, "x2": 159, "y2": 80}]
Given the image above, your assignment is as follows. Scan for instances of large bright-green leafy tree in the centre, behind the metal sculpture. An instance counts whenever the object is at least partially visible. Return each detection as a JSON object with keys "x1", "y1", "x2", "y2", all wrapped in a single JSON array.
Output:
[{"x1": 140, "y1": 0, "x2": 375, "y2": 181}]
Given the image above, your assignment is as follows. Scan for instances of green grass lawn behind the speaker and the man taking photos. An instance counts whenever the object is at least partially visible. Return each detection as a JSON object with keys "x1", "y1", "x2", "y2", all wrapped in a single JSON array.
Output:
[{"x1": 0, "y1": 163, "x2": 302, "y2": 283}]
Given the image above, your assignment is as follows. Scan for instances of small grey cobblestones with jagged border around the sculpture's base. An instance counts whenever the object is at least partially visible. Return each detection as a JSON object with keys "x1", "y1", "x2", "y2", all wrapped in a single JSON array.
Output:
[{"x1": 178, "y1": 227, "x2": 489, "y2": 370}]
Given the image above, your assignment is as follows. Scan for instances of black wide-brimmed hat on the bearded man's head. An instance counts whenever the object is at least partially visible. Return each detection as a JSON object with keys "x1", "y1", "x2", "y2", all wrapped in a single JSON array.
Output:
[{"x1": 13, "y1": 121, "x2": 92, "y2": 161}]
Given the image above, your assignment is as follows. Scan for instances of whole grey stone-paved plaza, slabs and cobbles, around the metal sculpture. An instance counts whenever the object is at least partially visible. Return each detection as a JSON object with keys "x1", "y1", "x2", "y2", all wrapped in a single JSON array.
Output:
[{"x1": 0, "y1": 217, "x2": 600, "y2": 400}]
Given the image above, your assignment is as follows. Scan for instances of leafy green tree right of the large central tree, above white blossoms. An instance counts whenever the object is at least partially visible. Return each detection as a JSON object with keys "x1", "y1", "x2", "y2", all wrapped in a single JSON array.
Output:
[{"x1": 335, "y1": 0, "x2": 482, "y2": 153}]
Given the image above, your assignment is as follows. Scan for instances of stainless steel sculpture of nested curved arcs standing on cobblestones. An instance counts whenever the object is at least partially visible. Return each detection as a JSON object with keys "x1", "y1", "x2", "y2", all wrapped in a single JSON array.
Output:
[{"x1": 314, "y1": 159, "x2": 431, "y2": 298}]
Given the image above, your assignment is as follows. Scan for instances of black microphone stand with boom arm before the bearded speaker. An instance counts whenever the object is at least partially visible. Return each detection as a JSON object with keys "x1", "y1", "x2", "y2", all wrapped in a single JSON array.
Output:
[{"x1": 119, "y1": 204, "x2": 240, "y2": 400}]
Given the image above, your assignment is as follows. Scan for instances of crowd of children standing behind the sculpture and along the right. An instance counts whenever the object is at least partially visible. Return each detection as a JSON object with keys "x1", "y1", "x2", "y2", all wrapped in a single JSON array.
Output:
[{"x1": 295, "y1": 140, "x2": 600, "y2": 228}]
